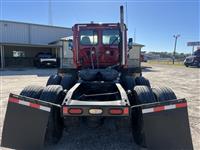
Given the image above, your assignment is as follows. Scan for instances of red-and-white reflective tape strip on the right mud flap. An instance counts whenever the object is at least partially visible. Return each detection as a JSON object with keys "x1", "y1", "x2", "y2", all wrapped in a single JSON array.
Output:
[{"x1": 142, "y1": 103, "x2": 187, "y2": 114}]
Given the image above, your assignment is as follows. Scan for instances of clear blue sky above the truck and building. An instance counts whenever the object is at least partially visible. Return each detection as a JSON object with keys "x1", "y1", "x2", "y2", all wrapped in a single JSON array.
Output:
[{"x1": 0, "y1": 0, "x2": 200, "y2": 53}]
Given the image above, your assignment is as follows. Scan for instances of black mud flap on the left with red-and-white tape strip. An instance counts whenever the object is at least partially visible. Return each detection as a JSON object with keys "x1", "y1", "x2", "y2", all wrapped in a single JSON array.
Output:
[{"x1": 1, "y1": 94, "x2": 60, "y2": 150}]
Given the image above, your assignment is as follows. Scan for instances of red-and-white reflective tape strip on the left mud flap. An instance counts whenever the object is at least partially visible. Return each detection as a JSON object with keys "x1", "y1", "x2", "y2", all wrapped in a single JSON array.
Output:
[{"x1": 8, "y1": 97, "x2": 51, "y2": 112}]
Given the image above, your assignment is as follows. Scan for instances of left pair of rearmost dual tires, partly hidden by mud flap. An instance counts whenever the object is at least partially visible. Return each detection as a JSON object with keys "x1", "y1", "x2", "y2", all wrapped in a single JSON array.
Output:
[{"x1": 20, "y1": 85, "x2": 64, "y2": 145}]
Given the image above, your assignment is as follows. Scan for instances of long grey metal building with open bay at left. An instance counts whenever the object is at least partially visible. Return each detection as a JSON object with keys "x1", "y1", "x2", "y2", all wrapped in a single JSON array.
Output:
[{"x1": 0, "y1": 20, "x2": 72, "y2": 69}]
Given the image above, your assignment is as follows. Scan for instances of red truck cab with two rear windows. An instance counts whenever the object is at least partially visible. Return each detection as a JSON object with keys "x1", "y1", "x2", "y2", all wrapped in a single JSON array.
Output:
[{"x1": 73, "y1": 23, "x2": 127, "y2": 69}]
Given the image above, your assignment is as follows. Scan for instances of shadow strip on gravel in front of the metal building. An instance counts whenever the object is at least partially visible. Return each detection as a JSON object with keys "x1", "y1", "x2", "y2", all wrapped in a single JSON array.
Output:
[{"x1": 0, "y1": 68, "x2": 57, "y2": 77}]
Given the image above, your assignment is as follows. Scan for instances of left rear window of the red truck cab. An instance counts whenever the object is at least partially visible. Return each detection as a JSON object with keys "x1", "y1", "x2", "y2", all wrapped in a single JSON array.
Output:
[{"x1": 80, "y1": 30, "x2": 98, "y2": 45}]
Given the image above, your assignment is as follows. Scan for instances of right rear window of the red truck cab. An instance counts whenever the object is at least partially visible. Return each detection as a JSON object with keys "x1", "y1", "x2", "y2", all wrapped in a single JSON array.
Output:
[{"x1": 102, "y1": 29, "x2": 120, "y2": 45}]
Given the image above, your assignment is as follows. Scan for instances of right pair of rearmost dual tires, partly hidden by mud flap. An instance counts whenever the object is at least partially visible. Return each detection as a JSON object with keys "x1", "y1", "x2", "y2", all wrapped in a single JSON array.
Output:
[{"x1": 131, "y1": 86, "x2": 176, "y2": 147}]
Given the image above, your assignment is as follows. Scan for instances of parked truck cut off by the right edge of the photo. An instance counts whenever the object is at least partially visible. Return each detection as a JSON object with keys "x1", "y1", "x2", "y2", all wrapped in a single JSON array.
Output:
[{"x1": 184, "y1": 49, "x2": 200, "y2": 67}]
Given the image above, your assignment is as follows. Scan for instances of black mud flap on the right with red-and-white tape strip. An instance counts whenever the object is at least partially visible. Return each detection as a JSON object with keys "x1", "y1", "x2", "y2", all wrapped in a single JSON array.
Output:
[{"x1": 134, "y1": 99, "x2": 193, "y2": 150}]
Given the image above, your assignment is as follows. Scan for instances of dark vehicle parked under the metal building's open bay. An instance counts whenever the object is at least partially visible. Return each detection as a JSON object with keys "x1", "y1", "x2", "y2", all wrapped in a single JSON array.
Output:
[{"x1": 34, "y1": 52, "x2": 59, "y2": 68}]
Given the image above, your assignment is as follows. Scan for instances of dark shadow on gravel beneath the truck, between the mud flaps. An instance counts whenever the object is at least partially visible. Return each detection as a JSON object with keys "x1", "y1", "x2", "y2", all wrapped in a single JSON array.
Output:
[{"x1": 45, "y1": 118, "x2": 145, "y2": 150}]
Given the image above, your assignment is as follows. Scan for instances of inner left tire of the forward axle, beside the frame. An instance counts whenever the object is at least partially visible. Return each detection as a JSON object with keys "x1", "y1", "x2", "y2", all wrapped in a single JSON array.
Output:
[{"x1": 60, "y1": 75, "x2": 75, "y2": 90}]
